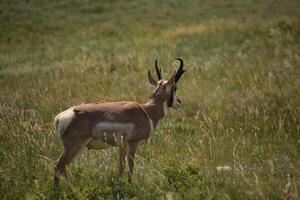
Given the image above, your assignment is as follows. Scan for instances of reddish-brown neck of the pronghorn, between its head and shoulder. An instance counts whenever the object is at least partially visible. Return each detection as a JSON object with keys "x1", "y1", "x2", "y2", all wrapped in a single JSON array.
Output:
[{"x1": 142, "y1": 99, "x2": 165, "y2": 128}]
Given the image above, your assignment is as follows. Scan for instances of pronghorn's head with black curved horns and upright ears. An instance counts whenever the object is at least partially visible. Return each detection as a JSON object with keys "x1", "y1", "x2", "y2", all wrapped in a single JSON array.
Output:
[{"x1": 148, "y1": 58, "x2": 185, "y2": 109}]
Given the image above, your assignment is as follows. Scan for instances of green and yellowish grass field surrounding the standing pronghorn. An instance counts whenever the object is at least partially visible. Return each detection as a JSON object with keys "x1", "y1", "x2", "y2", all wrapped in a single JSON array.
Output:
[{"x1": 0, "y1": 0, "x2": 300, "y2": 200}]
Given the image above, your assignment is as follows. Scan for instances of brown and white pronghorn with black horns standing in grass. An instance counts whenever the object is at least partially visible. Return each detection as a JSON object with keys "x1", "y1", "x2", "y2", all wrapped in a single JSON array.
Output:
[{"x1": 54, "y1": 58, "x2": 185, "y2": 187}]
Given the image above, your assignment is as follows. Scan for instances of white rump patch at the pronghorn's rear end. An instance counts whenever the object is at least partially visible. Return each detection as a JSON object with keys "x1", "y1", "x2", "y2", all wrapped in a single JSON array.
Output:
[{"x1": 54, "y1": 107, "x2": 75, "y2": 136}]
